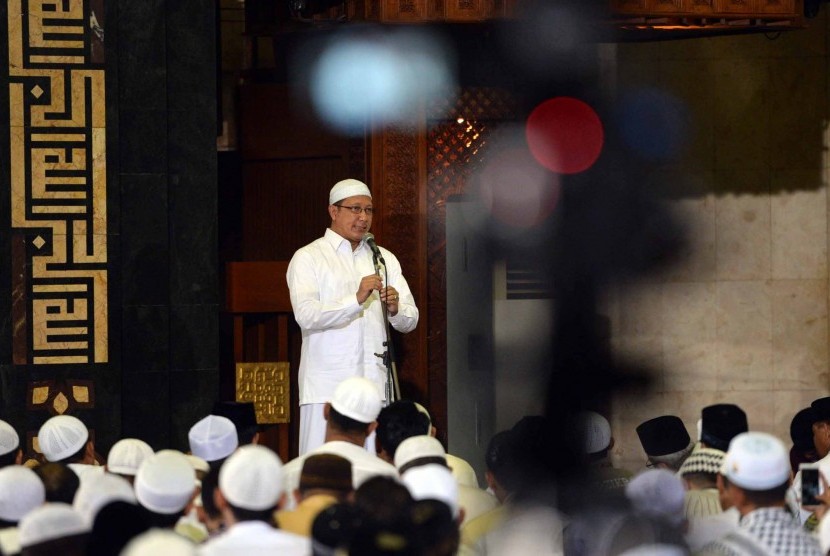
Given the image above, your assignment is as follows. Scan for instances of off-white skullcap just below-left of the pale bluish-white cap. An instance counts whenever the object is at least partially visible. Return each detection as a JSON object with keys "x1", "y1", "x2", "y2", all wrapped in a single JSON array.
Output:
[{"x1": 135, "y1": 450, "x2": 196, "y2": 515}]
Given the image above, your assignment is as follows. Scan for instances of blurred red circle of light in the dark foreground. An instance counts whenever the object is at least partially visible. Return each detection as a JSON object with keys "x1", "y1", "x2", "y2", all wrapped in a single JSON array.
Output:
[{"x1": 525, "y1": 97, "x2": 605, "y2": 174}]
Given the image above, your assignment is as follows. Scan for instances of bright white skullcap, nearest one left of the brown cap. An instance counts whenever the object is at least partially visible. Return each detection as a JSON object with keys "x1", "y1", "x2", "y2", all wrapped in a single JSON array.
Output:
[{"x1": 219, "y1": 444, "x2": 282, "y2": 511}]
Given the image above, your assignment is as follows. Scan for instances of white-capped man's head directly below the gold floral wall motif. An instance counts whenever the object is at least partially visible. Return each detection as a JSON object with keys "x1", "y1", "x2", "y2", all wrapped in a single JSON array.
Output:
[{"x1": 37, "y1": 415, "x2": 104, "y2": 480}]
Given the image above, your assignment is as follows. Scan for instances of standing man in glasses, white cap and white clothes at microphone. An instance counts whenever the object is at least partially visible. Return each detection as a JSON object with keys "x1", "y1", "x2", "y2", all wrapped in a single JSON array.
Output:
[{"x1": 286, "y1": 179, "x2": 418, "y2": 455}]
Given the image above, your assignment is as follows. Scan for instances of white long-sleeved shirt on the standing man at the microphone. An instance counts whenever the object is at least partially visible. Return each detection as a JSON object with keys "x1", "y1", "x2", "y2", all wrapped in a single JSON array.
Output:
[{"x1": 286, "y1": 229, "x2": 418, "y2": 405}]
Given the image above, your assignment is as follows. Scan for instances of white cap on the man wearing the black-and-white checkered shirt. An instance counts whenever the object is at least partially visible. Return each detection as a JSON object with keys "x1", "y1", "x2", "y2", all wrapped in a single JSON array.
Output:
[{"x1": 721, "y1": 432, "x2": 790, "y2": 490}]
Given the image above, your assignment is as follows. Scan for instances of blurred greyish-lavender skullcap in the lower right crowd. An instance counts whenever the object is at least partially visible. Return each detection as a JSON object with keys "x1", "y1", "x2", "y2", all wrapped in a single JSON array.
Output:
[{"x1": 625, "y1": 469, "x2": 686, "y2": 525}]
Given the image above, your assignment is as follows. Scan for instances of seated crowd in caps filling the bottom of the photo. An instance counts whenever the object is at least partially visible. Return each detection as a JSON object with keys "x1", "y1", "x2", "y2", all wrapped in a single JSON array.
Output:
[{"x1": 0, "y1": 377, "x2": 830, "y2": 556}]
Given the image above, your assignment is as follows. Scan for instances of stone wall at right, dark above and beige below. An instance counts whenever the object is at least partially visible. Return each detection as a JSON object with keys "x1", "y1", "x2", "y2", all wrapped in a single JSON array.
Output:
[{"x1": 607, "y1": 15, "x2": 830, "y2": 470}]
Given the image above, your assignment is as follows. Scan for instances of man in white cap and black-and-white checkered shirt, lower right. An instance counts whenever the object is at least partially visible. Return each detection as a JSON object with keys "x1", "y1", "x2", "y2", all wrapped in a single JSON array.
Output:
[{"x1": 699, "y1": 432, "x2": 821, "y2": 556}]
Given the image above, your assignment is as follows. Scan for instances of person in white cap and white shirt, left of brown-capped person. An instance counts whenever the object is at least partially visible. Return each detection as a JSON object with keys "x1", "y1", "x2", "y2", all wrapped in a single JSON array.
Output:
[{"x1": 199, "y1": 444, "x2": 311, "y2": 556}]
